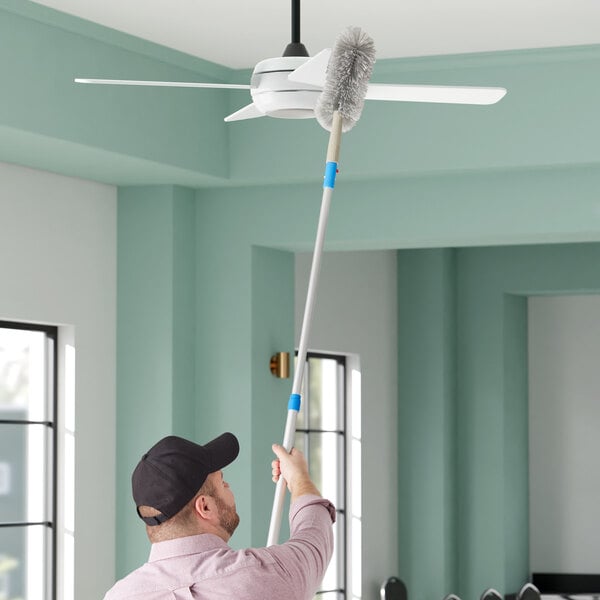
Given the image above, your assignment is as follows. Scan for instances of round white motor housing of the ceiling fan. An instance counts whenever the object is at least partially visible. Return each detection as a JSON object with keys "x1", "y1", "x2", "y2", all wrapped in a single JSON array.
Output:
[{"x1": 250, "y1": 56, "x2": 322, "y2": 119}]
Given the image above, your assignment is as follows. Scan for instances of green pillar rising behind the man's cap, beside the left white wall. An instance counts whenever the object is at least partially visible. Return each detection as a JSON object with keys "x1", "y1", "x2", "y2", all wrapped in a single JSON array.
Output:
[{"x1": 116, "y1": 186, "x2": 196, "y2": 575}]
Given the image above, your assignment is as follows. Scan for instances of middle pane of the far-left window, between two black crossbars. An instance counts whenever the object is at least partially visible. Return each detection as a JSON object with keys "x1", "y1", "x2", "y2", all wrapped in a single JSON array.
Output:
[{"x1": 0, "y1": 424, "x2": 49, "y2": 524}]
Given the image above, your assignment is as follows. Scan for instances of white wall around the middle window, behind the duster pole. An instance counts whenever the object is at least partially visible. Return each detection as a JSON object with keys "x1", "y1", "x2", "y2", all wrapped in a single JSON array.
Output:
[{"x1": 296, "y1": 252, "x2": 398, "y2": 599}]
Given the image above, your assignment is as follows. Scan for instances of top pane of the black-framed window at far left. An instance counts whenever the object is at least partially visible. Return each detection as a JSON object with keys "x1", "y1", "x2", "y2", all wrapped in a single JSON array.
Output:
[{"x1": 0, "y1": 328, "x2": 48, "y2": 421}]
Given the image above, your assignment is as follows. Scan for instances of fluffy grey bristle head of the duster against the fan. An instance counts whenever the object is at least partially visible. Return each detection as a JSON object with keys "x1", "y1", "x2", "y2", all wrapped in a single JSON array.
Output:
[{"x1": 315, "y1": 27, "x2": 375, "y2": 131}]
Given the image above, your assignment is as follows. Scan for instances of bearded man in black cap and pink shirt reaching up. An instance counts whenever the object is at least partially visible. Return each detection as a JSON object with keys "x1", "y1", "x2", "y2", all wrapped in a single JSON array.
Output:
[{"x1": 105, "y1": 433, "x2": 335, "y2": 600}]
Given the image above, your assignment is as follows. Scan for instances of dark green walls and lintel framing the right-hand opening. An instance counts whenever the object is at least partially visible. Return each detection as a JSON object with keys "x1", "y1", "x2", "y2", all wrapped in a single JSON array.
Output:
[{"x1": 398, "y1": 244, "x2": 600, "y2": 599}]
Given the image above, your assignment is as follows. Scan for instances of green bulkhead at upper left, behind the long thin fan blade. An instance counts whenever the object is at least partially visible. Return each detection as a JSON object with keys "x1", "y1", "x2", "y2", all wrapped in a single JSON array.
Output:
[{"x1": 0, "y1": 0, "x2": 231, "y2": 185}]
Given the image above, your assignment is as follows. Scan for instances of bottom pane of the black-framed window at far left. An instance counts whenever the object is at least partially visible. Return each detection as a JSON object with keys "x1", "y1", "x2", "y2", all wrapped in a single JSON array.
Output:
[{"x1": 0, "y1": 525, "x2": 49, "y2": 600}]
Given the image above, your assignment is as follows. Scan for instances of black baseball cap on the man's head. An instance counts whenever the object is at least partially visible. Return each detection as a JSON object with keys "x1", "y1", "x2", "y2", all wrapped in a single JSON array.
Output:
[{"x1": 131, "y1": 432, "x2": 240, "y2": 525}]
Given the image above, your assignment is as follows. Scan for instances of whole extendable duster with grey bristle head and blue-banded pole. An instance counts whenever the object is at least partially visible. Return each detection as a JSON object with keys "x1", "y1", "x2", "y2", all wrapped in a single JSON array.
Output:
[{"x1": 267, "y1": 27, "x2": 375, "y2": 546}]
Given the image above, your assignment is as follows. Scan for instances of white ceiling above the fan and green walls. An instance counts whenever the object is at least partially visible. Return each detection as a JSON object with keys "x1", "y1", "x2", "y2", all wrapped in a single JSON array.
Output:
[{"x1": 30, "y1": 0, "x2": 600, "y2": 69}]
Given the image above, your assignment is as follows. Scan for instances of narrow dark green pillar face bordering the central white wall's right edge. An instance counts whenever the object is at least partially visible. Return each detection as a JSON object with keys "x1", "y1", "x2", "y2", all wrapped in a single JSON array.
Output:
[{"x1": 398, "y1": 249, "x2": 458, "y2": 598}]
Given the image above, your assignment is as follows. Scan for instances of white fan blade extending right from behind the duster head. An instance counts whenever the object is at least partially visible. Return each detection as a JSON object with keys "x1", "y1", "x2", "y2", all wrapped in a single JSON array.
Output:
[{"x1": 366, "y1": 83, "x2": 506, "y2": 104}]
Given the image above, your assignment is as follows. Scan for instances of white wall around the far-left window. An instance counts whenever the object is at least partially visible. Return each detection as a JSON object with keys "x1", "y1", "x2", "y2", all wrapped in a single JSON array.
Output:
[{"x1": 0, "y1": 163, "x2": 116, "y2": 599}]
